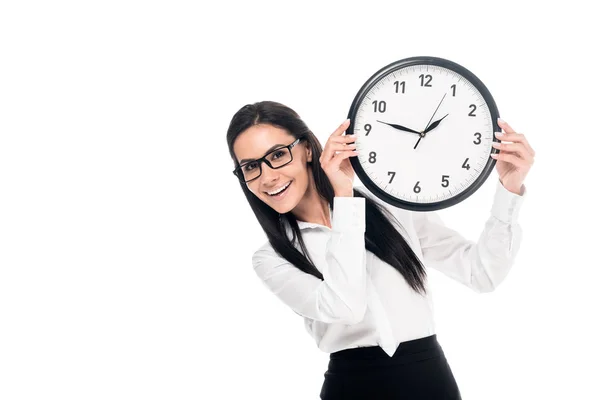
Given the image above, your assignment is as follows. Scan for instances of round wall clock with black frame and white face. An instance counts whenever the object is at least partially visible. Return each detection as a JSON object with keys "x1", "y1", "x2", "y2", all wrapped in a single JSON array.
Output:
[{"x1": 346, "y1": 57, "x2": 500, "y2": 211}]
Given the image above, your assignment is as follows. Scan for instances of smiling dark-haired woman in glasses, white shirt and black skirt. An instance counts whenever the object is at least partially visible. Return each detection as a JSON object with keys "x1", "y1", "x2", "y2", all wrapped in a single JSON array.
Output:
[{"x1": 227, "y1": 101, "x2": 534, "y2": 400}]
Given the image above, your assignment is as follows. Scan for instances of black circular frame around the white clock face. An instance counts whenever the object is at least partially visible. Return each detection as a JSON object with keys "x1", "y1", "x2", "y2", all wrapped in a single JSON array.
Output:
[{"x1": 346, "y1": 56, "x2": 501, "y2": 211}]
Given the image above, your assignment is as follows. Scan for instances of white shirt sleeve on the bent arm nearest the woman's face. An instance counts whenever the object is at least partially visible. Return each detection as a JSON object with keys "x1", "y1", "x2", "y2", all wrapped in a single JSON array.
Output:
[{"x1": 252, "y1": 197, "x2": 367, "y2": 324}]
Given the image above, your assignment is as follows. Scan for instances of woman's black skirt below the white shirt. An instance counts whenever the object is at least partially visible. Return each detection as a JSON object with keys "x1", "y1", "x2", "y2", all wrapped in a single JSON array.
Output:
[{"x1": 320, "y1": 334, "x2": 461, "y2": 400}]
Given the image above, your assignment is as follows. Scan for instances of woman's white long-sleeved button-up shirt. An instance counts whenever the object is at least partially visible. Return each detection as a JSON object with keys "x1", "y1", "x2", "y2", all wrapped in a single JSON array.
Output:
[{"x1": 252, "y1": 180, "x2": 526, "y2": 357}]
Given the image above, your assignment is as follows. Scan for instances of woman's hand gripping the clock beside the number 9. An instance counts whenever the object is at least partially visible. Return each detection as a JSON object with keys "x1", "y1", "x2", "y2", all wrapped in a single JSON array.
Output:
[{"x1": 319, "y1": 119, "x2": 358, "y2": 197}]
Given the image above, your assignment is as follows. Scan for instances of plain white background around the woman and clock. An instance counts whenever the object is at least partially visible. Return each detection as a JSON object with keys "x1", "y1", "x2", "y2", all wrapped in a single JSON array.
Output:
[{"x1": 0, "y1": 1, "x2": 600, "y2": 400}]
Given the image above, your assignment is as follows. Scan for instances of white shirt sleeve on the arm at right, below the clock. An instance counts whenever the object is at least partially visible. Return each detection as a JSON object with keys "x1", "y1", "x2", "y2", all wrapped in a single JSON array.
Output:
[{"x1": 413, "y1": 180, "x2": 527, "y2": 293}]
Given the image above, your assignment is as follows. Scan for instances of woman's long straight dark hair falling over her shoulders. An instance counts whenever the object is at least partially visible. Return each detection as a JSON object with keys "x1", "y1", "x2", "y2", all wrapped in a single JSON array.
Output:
[{"x1": 227, "y1": 101, "x2": 427, "y2": 295}]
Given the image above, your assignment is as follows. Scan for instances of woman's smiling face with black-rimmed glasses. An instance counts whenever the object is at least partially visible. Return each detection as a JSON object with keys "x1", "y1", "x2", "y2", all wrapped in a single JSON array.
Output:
[{"x1": 233, "y1": 124, "x2": 312, "y2": 214}]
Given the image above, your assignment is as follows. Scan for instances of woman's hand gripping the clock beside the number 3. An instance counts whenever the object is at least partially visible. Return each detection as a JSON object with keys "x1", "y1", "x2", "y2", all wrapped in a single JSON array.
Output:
[{"x1": 491, "y1": 118, "x2": 535, "y2": 195}]
